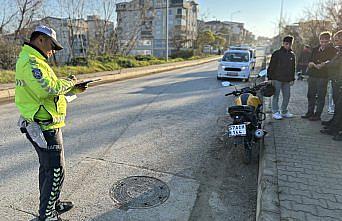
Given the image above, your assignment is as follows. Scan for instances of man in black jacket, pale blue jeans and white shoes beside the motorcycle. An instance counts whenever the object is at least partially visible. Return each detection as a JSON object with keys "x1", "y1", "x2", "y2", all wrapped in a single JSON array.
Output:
[{"x1": 267, "y1": 36, "x2": 296, "y2": 120}]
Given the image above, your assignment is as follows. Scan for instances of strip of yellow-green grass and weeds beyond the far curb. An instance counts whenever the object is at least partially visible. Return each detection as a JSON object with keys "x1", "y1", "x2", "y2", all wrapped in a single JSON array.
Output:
[{"x1": 0, "y1": 56, "x2": 212, "y2": 84}]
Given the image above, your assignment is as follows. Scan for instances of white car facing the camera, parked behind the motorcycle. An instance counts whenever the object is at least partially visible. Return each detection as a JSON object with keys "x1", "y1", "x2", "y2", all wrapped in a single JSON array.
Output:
[{"x1": 217, "y1": 50, "x2": 254, "y2": 81}]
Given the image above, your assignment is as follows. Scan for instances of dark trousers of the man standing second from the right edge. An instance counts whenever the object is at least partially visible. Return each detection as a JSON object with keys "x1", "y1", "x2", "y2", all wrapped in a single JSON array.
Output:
[{"x1": 307, "y1": 77, "x2": 328, "y2": 116}]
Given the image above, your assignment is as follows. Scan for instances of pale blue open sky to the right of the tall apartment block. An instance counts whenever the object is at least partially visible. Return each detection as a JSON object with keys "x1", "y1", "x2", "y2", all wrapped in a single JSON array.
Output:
[{"x1": 197, "y1": 0, "x2": 317, "y2": 37}]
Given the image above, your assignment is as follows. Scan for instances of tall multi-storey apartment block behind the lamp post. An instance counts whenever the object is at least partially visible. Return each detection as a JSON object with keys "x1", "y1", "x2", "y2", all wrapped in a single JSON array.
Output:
[{"x1": 116, "y1": 0, "x2": 198, "y2": 57}]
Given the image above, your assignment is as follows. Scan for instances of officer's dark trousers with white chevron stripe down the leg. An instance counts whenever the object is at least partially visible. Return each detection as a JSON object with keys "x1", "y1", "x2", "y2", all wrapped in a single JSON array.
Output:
[{"x1": 26, "y1": 129, "x2": 65, "y2": 218}]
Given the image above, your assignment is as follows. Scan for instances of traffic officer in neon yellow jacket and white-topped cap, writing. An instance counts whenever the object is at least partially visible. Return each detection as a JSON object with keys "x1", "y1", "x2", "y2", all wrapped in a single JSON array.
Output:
[{"x1": 15, "y1": 26, "x2": 85, "y2": 221}]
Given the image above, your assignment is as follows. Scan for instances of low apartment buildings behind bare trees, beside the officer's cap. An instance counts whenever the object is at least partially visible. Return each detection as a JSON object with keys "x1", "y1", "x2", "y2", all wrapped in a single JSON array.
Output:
[{"x1": 8, "y1": 15, "x2": 114, "y2": 64}]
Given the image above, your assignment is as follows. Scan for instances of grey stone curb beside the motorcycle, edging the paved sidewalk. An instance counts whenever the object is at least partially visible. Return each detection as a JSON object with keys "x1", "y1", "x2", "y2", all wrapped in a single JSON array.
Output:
[{"x1": 256, "y1": 98, "x2": 280, "y2": 221}]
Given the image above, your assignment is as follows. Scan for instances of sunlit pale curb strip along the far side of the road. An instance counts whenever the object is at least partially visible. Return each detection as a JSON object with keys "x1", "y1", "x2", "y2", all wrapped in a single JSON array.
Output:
[{"x1": 0, "y1": 56, "x2": 219, "y2": 102}]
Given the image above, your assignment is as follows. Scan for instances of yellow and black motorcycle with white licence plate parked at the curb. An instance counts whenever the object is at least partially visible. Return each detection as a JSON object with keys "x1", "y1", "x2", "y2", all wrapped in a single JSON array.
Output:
[{"x1": 225, "y1": 82, "x2": 274, "y2": 164}]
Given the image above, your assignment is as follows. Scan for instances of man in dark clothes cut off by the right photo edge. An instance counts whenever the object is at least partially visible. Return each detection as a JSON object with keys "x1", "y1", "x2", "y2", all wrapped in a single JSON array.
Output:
[{"x1": 316, "y1": 30, "x2": 342, "y2": 141}]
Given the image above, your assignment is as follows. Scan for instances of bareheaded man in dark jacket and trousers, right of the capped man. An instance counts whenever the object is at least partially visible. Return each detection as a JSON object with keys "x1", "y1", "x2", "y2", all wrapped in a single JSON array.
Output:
[{"x1": 302, "y1": 32, "x2": 337, "y2": 121}]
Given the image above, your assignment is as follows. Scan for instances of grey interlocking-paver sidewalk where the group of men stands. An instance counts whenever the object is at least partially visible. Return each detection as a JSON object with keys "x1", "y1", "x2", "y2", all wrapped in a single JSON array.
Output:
[{"x1": 257, "y1": 81, "x2": 342, "y2": 221}]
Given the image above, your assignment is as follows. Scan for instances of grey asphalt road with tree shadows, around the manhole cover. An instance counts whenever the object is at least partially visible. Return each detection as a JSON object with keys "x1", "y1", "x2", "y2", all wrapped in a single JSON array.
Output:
[{"x1": 0, "y1": 62, "x2": 258, "y2": 221}]
